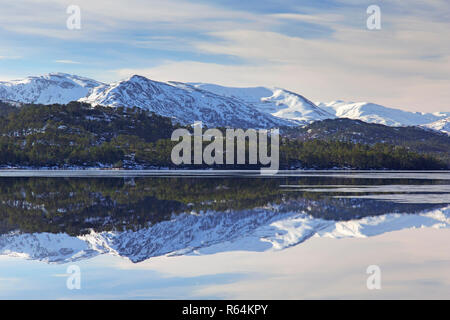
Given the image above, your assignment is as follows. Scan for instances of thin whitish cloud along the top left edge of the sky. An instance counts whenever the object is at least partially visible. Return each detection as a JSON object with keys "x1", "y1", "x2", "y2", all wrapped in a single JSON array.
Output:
[{"x1": 0, "y1": 0, "x2": 263, "y2": 41}]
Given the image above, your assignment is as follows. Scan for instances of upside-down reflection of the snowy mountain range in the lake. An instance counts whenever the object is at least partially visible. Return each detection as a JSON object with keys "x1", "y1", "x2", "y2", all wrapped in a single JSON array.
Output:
[{"x1": 0, "y1": 207, "x2": 450, "y2": 263}]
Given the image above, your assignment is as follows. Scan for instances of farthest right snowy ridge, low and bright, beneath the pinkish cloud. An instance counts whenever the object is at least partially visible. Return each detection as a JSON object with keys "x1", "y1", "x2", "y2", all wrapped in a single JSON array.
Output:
[{"x1": 318, "y1": 100, "x2": 450, "y2": 126}]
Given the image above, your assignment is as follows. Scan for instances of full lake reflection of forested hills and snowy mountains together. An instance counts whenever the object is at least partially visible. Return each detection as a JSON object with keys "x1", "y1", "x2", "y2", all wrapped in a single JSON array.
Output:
[{"x1": 0, "y1": 178, "x2": 450, "y2": 263}]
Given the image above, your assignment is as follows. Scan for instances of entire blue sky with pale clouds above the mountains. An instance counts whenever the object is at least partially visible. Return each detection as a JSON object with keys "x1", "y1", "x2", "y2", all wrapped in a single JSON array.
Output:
[{"x1": 0, "y1": 0, "x2": 450, "y2": 112}]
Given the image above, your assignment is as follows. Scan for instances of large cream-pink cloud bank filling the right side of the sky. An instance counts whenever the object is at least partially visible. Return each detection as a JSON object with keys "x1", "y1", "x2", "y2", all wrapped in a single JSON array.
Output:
[{"x1": 111, "y1": 0, "x2": 450, "y2": 112}]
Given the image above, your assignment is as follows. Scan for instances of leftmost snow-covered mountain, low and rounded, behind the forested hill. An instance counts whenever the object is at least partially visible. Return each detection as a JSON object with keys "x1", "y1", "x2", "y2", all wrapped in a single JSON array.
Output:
[{"x1": 0, "y1": 73, "x2": 103, "y2": 104}]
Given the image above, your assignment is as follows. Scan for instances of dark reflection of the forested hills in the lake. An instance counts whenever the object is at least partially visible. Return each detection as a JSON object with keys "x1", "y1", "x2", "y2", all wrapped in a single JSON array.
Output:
[{"x1": 0, "y1": 177, "x2": 441, "y2": 235}]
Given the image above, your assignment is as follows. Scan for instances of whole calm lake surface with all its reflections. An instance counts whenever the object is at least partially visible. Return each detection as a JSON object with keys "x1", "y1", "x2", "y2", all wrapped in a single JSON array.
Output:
[{"x1": 0, "y1": 170, "x2": 450, "y2": 299}]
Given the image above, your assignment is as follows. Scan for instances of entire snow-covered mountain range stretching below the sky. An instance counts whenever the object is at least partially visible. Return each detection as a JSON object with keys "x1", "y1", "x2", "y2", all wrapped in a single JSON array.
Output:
[{"x1": 0, "y1": 73, "x2": 450, "y2": 132}]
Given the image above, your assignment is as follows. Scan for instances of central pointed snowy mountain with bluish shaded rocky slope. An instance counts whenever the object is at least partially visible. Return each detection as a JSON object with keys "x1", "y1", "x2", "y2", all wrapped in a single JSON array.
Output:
[{"x1": 79, "y1": 75, "x2": 292, "y2": 128}]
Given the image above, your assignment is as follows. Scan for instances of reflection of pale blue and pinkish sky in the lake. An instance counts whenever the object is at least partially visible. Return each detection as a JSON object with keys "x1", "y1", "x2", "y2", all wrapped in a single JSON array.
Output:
[{"x1": 0, "y1": 228, "x2": 450, "y2": 300}]
